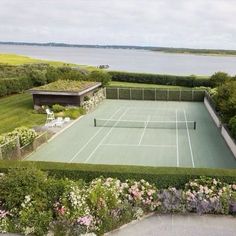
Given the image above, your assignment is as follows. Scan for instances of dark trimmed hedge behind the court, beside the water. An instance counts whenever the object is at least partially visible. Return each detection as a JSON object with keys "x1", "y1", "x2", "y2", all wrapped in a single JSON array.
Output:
[{"x1": 108, "y1": 71, "x2": 213, "y2": 87}]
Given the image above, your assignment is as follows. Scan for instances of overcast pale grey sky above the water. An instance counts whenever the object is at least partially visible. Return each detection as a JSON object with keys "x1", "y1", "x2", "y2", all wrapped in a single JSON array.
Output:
[{"x1": 0, "y1": 0, "x2": 236, "y2": 49}]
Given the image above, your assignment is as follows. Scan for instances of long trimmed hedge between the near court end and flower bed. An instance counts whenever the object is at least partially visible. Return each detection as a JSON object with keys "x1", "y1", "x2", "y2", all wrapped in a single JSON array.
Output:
[{"x1": 0, "y1": 161, "x2": 236, "y2": 188}]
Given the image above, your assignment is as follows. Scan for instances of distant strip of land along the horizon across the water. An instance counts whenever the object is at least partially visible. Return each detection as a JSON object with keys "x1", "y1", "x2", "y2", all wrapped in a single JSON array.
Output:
[{"x1": 0, "y1": 42, "x2": 236, "y2": 56}]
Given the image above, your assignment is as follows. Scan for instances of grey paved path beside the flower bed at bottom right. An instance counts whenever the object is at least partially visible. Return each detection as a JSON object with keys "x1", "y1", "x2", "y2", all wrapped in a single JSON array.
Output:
[{"x1": 107, "y1": 214, "x2": 236, "y2": 236}]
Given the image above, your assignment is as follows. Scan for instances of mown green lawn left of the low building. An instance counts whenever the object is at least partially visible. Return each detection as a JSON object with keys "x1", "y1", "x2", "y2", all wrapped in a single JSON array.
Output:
[{"x1": 0, "y1": 93, "x2": 46, "y2": 134}]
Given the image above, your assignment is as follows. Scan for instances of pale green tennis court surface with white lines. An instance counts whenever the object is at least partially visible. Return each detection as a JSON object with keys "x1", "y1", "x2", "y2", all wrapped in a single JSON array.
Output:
[{"x1": 27, "y1": 100, "x2": 236, "y2": 168}]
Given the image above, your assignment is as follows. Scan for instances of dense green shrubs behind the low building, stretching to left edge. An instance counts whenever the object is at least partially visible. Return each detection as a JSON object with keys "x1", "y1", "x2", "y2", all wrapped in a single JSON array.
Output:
[{"x1": 0, "y1": 63, "x2": 101, "y2": 97}]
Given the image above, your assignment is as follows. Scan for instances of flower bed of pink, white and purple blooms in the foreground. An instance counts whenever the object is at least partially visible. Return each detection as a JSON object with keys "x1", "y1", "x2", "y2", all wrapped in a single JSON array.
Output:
[{"x1": 0, "y1": 167, "x2": 236, "y2": 235}]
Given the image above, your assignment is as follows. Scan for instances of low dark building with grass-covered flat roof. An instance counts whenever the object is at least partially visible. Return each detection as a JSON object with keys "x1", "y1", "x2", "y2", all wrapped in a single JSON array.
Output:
[{"x1": 29, "y1": 80, "x2": 102, "y2": 109}]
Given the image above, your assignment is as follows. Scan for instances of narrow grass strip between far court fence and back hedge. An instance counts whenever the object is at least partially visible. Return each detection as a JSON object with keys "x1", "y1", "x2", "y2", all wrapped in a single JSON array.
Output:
[{"x1": 108, "y1": 81, "x2": 192, "y2": 89}]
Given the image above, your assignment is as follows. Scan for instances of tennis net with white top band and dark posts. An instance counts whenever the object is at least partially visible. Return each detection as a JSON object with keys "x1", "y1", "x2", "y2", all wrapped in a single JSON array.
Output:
[{"x1": 94, "y1": 118, "x2": 196, "y2": 129}]
